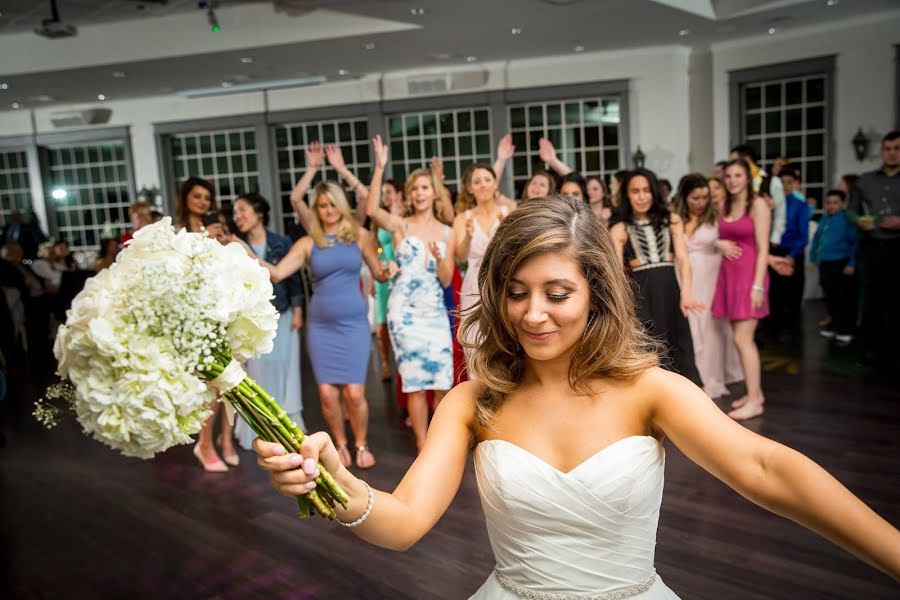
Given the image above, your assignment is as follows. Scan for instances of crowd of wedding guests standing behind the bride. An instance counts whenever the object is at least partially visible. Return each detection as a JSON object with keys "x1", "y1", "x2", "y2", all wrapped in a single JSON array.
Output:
[{"x1": 0, "y1": 131, "x2": 900, "y2": 460}]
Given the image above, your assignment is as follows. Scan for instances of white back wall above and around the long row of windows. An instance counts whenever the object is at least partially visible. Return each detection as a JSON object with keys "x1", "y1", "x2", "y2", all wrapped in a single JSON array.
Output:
[{"x1": 0, "y1": 46, "x2": 691, "y2": 188}]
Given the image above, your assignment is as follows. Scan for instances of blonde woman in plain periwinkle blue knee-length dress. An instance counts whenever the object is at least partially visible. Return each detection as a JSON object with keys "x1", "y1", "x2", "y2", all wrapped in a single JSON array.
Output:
[{"x1": 261, "y1": 181, "x2": 387, "y2": 469}]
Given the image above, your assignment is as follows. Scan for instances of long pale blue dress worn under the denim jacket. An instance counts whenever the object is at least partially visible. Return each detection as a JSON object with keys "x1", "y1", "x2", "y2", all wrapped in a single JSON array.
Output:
[{"x1": 234, "y1": 244, "x2": 306, "y2": 450}]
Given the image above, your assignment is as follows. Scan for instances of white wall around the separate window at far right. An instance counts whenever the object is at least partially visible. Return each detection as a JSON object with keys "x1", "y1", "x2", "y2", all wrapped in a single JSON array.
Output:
[{"x1": 712, "y1": 11, "x2": 900, "y2": 183}]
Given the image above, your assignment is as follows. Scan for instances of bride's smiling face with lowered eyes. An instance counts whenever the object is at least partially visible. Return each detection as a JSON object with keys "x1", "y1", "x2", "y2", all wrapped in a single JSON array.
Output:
[{"x1": 506, "y1": 252, "x2": 590, "y2": 361}]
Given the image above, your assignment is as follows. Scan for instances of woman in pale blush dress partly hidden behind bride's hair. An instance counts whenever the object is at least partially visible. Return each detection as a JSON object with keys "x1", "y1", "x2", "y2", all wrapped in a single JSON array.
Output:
[{"x1": 453, "y1": 164, "x2": 509, "y2": 378}]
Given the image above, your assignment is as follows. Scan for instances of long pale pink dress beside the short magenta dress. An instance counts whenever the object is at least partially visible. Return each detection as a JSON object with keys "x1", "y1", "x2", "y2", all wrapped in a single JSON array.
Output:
[{"x1": 685, "y1": 224, "x2": 744, "y2": 398}]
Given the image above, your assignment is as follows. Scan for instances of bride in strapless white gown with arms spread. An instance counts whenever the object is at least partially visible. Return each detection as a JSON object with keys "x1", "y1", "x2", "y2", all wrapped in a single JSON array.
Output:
[{"x1": 254, "y1": 197, "x2": 900, "y2": 600}]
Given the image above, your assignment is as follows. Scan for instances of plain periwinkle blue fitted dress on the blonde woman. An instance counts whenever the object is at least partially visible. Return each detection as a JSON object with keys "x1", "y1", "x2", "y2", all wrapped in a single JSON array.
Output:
[{"x1": 306, "y1": 235, "x2": 372, "y2": 385}]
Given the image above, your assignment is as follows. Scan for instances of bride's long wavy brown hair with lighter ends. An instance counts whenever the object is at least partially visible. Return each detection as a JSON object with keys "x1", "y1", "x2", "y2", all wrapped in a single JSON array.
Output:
[{"x1": 458, "y1": 195, "x2": 660, "y2": 427}]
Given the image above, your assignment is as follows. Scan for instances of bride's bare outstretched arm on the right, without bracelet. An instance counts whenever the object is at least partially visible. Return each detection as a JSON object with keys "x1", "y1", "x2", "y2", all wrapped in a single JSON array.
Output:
[{"x1": 642, "y1": 370, "x2": 900, "y2": 580}]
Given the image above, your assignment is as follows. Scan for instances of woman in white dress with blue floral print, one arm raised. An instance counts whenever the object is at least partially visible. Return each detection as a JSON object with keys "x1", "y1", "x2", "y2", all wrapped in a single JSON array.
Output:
[{"x1": 368, "y1": 136, "x2": 456, "y2": 450}]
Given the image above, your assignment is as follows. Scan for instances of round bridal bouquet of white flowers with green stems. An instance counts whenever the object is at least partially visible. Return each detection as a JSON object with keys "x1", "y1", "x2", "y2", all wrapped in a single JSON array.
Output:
[{"x1": 35, "y1": 217, "x2": 349, "y2": 518}]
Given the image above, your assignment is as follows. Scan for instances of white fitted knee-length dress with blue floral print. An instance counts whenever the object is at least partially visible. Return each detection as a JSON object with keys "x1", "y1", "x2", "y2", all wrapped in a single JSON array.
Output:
[{"x1": 388, "y1": 223, "x2": 453, "y2": 393}]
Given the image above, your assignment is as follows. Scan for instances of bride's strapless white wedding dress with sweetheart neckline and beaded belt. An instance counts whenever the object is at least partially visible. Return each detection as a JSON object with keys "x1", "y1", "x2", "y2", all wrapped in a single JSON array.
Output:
[{"x1": 472, "y1": 436, "x2": 678, "y2": 600}]
